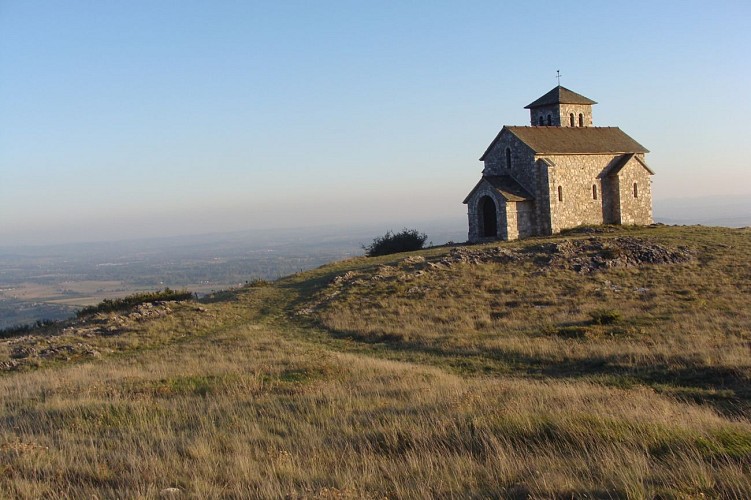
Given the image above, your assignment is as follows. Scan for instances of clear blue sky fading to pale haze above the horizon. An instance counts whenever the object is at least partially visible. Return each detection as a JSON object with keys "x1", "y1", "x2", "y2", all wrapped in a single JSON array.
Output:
[{"x1": 0, "y1": 0, "x2": 751, "y2": 244}]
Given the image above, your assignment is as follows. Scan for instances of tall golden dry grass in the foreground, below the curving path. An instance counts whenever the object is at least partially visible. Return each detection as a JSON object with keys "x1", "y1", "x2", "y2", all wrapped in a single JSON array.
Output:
[{"x1": 0, "y1": 314, "x2": 751, "y2": 498}]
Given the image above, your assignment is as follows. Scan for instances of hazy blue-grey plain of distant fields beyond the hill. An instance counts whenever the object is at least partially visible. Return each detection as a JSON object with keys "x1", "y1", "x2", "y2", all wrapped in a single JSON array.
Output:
[{"x1": 0, "y1": 225, "x2": 465, "y2": 328}]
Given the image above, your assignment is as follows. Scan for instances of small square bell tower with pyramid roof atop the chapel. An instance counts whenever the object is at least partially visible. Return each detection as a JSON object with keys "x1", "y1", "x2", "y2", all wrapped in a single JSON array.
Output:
[{"x1": 524, "y1": 85, "x2": 597, "y2": 127}]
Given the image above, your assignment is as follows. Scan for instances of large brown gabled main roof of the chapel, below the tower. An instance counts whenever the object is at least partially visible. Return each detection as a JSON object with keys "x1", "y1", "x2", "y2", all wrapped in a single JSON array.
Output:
[{"x1": 480, "y1": 126, "x2": 649, "y2": 161}]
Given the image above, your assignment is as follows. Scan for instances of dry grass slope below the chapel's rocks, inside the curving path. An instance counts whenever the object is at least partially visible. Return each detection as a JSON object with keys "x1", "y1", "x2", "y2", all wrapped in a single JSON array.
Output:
[{"x1": 315, "y1": 228, "x2": 751, "y2": 414}]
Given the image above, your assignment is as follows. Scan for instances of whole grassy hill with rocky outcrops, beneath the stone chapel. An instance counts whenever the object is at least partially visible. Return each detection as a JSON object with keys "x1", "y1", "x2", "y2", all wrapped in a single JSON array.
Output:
[{"x1": 0, "y1": 226, "x2": 751, "y2": 498}]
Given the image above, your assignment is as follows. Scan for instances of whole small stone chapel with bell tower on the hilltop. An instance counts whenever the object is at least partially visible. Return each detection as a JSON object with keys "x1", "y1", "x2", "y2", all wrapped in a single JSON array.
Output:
[{"x1": 464, "y1": 85, "x2": 654, "y2": 242}]
